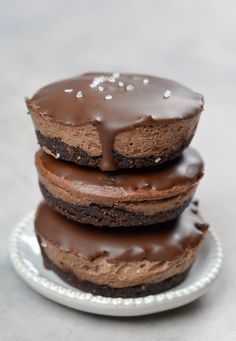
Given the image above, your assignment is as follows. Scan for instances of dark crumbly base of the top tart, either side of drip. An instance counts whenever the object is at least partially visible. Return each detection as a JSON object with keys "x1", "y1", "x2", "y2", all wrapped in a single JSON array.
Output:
[{"x1": 36, "y1": 131, "x2": 191, "y2": 169}]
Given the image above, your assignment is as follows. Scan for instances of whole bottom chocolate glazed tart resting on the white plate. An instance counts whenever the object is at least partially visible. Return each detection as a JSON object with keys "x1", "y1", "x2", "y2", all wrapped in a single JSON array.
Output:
[{"x1": 35, "y1": 203, "x2": 208, "y2": 297}]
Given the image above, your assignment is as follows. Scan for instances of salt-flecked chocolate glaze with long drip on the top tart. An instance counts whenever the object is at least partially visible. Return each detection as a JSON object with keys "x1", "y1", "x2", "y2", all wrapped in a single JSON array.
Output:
[{"x1": 26, "y1": 73, "x2": 203, "y2": 171}]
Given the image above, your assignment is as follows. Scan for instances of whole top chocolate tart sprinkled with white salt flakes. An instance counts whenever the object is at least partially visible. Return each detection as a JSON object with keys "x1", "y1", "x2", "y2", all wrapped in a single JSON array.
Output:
[{"x1": 26, "y1": 73, "x2": 203, "y2": 171}]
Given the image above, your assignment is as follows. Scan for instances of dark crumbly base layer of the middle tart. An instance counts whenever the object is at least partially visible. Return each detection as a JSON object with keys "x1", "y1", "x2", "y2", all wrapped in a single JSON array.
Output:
[{"x1": 39, "y1": 183, "x2": 191, "y2": 227}]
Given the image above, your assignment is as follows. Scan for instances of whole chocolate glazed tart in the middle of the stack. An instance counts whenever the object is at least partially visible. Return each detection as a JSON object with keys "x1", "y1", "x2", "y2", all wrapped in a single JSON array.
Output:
[{"x1": 35, "y1": 148, "x2": 203, "y2": 228}]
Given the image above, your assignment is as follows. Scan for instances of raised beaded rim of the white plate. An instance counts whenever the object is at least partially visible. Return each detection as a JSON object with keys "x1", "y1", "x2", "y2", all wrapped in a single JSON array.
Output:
[{"x1": 8, "y1": 210, "x2": 223, "y2": 316}]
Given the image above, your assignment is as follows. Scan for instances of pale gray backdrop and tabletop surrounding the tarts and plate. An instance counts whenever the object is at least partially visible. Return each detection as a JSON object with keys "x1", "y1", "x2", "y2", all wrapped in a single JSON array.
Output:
[{"x1": 0, "y1": 0, "x2": 236, "y2": 341}]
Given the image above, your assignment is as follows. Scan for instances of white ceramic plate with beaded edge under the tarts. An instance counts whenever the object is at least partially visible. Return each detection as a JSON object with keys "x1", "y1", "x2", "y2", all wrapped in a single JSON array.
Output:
[{"x1": 9, "y1": 212, "x2": 223, "y2": 316}]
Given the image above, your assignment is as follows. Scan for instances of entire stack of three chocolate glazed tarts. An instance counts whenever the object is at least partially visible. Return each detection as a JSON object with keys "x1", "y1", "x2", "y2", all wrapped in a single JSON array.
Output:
[{"x1": 26, "y1": 73, "x2": 208, "y2": 297}]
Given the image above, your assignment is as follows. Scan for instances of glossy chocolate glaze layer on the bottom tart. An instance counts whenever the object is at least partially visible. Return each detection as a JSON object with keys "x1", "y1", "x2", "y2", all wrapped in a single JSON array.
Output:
[{"x1": 35, "y1": 202, "x2": 208, "y2": 262}]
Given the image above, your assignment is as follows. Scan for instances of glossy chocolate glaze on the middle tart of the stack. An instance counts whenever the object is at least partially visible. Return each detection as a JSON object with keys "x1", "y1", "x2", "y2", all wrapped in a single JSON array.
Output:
[{"x1": 36, "y1": 148, "x2": 203, "y2": 191}]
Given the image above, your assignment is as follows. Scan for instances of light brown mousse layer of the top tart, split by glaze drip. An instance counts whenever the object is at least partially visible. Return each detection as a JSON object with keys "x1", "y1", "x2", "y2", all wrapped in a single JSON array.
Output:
[{"x1": 29, "y1": 110, "x2": 200, "y2": 158}]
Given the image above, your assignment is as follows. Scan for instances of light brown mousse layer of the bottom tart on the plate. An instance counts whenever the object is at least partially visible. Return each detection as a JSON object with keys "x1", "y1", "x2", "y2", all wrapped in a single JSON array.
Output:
[{"x1": 39, "y1": 235, "x2": 203, "y2": 288}]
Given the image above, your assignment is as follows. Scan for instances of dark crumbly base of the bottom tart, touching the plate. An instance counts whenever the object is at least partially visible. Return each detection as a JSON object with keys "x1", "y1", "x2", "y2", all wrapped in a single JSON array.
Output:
[{"x1": 41, "y1": 244, "x2": 190, "y2": 298}]
